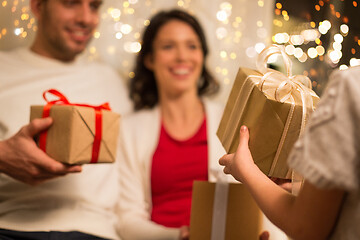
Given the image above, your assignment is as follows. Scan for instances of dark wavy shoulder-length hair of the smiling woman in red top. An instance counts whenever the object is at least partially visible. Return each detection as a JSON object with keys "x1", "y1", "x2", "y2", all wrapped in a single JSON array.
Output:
[{"x1": 130, "y1": 9, "x2": 219, "y2": 110}]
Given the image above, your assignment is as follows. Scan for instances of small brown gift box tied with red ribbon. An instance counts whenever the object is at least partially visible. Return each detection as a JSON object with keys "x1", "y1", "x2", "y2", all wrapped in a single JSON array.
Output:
[{"x1": 30, "y1": 89, "x2": 120, "y2": 164}]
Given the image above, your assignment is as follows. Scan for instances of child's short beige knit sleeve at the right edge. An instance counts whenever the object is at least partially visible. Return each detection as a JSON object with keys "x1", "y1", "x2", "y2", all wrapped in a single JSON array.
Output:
[{"x1": 288, "y1": 68, "x2": 360, "y2": 191}]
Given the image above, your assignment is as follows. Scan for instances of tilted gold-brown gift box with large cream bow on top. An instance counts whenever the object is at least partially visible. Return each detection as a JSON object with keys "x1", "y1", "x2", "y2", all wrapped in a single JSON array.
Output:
[{"x1": 217, "y1": 45, "x2": 319, "y2": 179}]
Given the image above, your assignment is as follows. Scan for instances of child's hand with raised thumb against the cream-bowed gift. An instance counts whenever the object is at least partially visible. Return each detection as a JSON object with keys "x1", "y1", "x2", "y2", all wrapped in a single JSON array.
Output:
[{"x1": 219, "y1": 126, "x2": 255, "y2": 182}]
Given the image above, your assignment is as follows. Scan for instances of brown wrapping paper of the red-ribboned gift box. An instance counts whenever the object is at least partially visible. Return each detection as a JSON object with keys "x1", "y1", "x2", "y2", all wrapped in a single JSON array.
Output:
[{"x1": 30, "y1": 105, "x2": 120, "y2": 164}]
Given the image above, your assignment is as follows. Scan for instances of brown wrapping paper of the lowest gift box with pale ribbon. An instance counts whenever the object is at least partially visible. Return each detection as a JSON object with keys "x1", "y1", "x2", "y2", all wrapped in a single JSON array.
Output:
[{"x1": 190, "y1": 181, "x2": 263, "y2": 240}]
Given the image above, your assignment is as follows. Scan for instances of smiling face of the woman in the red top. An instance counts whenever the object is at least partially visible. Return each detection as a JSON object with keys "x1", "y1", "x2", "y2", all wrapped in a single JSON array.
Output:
[{"x1": 145, "y1": 20, "x2": 204, "y2": 96}]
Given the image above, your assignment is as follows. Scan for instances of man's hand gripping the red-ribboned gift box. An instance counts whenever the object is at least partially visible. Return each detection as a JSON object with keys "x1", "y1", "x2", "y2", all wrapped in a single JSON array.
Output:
[{"x1": 0, "y1": 118, "x2": 81, "y2": 185}]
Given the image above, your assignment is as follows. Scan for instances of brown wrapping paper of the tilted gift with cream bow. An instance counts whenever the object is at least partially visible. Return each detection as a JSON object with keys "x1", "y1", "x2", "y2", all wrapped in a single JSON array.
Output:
[{"x1": 217, "y1": 68, "x2": 319, "y2": 179}]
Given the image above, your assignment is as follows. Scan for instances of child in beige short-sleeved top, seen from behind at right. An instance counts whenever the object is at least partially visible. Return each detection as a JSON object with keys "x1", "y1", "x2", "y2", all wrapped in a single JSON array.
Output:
[{"x1": 219, "y1": 67, "x2": 360, "y2": 240}]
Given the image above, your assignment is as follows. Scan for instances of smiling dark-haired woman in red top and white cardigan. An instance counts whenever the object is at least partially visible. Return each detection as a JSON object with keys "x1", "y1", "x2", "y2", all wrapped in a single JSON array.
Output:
[{"x1": 119, "y1": 10, "x2": 225, "y2": 240}]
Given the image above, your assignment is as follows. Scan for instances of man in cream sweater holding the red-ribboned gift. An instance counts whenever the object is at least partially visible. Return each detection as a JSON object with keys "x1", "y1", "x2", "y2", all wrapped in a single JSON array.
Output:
[{"x1": 0, "y1": 0, "x2": 131, "y2": 239}]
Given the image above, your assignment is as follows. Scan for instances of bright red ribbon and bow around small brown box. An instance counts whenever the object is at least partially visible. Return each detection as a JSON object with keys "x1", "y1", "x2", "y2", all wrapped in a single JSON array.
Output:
[{"x1": 39, "y1": 89, "x2": 111, "y2": 163}]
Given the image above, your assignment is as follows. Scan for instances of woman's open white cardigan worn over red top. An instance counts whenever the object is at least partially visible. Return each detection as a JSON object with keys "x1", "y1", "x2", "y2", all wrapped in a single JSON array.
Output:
[{"x1": 118, "y1": 99, "x2": 231, "y2": 240}]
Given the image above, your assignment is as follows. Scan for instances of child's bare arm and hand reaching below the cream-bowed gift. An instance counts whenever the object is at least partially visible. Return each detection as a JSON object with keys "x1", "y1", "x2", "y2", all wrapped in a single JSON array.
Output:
[{"x1": 219, "y1": 126, "x2": 344, "y2": 240}]
